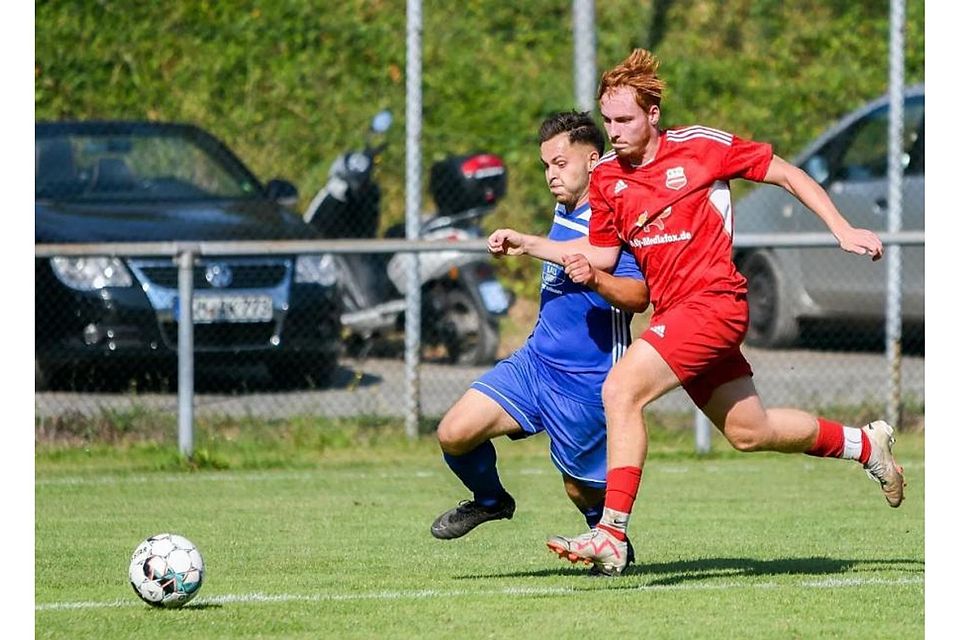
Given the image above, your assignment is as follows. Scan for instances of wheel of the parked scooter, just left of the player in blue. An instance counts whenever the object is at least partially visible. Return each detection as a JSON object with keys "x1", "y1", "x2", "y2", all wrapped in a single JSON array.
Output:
[{"x1": 441, "y1": 289, "x2": 500, "y2": 365}]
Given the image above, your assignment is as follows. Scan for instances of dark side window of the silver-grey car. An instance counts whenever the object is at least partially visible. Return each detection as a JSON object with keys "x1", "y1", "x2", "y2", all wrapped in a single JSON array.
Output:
[{"x1": 833, "y1": 97, "x2": 923, "y2": 181}]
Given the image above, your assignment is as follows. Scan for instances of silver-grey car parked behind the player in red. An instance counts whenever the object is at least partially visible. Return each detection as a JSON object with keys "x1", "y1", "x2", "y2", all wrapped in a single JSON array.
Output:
[{"x1": 734, "y1": 85, "x2": 924, "y2": 347}]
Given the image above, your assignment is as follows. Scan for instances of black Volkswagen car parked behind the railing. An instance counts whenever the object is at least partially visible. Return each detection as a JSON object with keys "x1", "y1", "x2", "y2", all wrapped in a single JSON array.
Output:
[{"x1": 35, "y1": 121, "x2": 342, "y2": 389}]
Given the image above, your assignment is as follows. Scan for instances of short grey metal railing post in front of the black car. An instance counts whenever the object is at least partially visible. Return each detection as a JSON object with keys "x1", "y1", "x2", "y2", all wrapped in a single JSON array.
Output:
[{"x1": 175, "y1": 249, "x2": 194, "y2": 457}]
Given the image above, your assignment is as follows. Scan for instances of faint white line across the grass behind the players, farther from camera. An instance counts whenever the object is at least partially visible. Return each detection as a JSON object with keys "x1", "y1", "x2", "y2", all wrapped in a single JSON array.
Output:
[{"x1": 34, "y1": 460, "x2": 924, "y2": 487}]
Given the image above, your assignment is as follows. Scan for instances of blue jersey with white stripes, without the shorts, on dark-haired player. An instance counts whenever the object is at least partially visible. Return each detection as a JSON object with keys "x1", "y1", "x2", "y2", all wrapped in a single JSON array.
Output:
[{"x1": 528, "y1": 203, "x2": 643, "y2": 378}]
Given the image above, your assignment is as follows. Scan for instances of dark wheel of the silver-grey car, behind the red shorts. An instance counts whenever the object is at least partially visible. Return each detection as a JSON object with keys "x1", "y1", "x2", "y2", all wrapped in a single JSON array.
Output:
[{"x1": 740, "y1": 251, "x2": 800, "y2": 348}]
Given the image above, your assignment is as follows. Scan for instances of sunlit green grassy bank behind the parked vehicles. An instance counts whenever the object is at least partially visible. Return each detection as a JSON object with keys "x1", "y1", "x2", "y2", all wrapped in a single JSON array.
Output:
[{"x1": 34, "y1": 0, "x2": 924, "y2": 296}]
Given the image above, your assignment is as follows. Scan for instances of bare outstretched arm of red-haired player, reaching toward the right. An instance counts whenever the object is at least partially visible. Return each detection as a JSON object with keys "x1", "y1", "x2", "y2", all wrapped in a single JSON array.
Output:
[{"x1": 763, "y1": 155, "x2": 883, "y2": 260}]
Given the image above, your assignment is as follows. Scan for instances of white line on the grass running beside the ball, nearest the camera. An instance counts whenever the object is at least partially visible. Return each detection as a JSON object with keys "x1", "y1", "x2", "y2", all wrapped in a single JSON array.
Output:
[{"x1": 34, "y1": 576, "x2": 924, "y2": 611}]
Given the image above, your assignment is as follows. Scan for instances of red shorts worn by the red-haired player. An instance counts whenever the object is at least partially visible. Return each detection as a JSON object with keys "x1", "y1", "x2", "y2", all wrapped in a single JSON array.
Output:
[{"x1": 640, "y1": 294, "x2": 753, "y2": 407}]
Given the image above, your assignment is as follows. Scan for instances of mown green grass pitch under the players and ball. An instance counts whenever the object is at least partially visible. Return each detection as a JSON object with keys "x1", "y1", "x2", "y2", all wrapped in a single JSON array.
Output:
[{"x1": 34, "y1": 420, "x2": 925, "y2": 639}]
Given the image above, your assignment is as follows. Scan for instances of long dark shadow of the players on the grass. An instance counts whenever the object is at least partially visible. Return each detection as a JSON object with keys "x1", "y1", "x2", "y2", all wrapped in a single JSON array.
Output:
[{"x1": 456, "y1": 558, "x2": 924, "y2": 586}]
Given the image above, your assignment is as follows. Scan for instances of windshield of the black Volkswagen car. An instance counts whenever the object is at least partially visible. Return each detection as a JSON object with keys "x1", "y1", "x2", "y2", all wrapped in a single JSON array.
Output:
[{"x1": 35, "y1": 129, "x2": 260, "y2": 202}]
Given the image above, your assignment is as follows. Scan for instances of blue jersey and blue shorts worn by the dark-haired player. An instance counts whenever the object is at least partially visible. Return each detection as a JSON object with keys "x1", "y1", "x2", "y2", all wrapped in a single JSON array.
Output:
[{"x1": 471, "y1": 204, "x2": 643, "y2": 480}]
